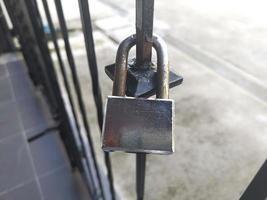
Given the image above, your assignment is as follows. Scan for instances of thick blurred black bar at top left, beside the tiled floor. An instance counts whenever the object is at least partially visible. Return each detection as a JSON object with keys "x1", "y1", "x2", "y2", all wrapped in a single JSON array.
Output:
[{"x1": 4, "y1": 0, "x2": 57, "y2": 112}]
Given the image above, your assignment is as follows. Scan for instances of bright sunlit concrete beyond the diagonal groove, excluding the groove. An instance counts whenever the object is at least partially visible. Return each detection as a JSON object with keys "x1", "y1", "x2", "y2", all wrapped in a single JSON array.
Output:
[{"x1": 101, "y1": 0, "x2": 267, "y2": 84}]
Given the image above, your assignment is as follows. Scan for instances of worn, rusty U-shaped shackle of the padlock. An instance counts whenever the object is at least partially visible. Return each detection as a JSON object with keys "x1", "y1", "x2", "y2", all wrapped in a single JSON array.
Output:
[{"x1": 112, "y1": 35, "x2": 169, "y2": 99}]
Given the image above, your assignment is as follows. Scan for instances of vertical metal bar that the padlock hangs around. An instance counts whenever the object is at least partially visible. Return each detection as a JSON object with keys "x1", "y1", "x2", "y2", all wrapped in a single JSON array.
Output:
[{"x1": 136, "y1": 0, "x2": 154, "y2": 200}]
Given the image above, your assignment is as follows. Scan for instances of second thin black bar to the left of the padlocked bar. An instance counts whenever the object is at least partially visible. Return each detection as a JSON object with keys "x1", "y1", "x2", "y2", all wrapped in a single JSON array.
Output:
[{"x1": 55, "y1": 0, "x2": 104, "y2": 198}]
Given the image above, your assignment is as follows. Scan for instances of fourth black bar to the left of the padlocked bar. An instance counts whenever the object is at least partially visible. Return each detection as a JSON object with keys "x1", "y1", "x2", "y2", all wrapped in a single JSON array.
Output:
[{"x1": 25, "y1": 0, "x2": 86, "y2": 172}]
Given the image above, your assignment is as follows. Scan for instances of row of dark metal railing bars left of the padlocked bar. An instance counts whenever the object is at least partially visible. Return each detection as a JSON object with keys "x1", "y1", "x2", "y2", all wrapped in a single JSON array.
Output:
[{"x1": 1, "y1": 0, "x2": 115, "y2": 199}]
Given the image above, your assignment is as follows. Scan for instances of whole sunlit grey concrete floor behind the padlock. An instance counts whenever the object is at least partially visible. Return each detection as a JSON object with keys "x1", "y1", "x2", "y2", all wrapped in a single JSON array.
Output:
[{"x1": 47, "y1": 0, "x2": 267, "y2": 200}]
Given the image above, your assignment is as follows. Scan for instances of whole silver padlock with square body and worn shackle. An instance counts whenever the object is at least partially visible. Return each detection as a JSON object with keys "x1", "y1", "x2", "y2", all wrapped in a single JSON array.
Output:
[{"x1": 102, "y1": 35, "x2": 174, "y2": 154}]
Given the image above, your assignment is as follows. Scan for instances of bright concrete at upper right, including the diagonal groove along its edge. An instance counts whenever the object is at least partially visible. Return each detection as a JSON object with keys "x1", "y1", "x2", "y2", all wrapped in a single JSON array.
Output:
[{"x1": 98, "y1": 0, "x2": 267, "y2": 101}]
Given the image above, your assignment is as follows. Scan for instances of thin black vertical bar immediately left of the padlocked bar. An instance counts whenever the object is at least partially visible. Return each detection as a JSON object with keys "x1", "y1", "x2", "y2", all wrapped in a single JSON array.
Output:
[{"x1": 78, "y1": 0, "x2": 115, "y2": 199}]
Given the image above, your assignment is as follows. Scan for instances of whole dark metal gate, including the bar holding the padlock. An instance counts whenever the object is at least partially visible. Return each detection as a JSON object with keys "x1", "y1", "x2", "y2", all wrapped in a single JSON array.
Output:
[{"x1": 0, "y1": 0, "x2": 182, "y2": 200}]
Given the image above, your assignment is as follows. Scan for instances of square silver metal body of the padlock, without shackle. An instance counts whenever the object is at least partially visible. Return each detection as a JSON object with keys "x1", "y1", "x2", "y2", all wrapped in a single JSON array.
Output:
[{"x1": 102, "y1": 96, "x2": 174, "y2": 154}]
